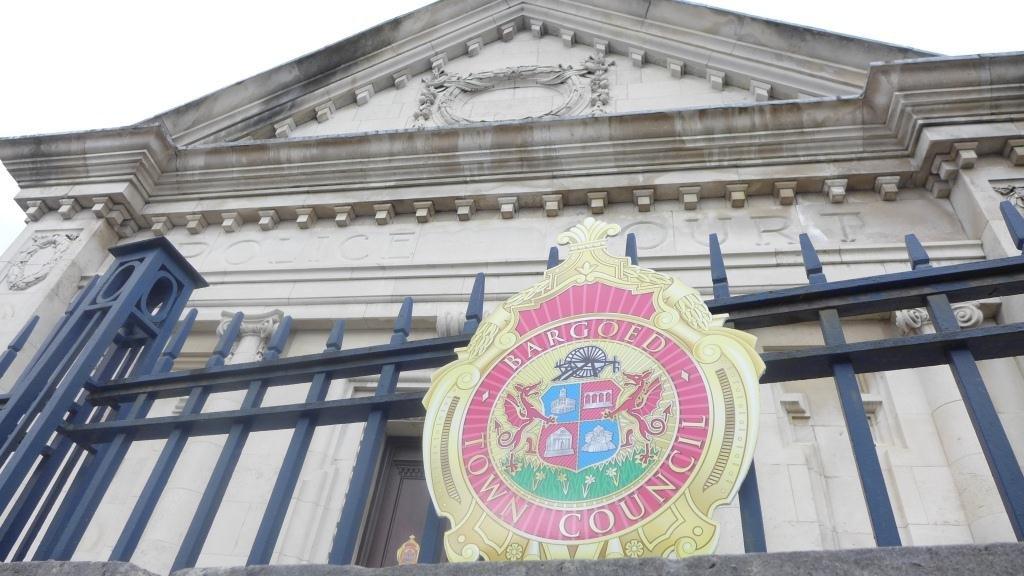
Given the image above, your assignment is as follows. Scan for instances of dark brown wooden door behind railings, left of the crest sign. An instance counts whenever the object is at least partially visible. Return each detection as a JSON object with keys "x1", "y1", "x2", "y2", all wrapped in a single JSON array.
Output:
[{"x1": 357, "y1": 437, "x2": 444, "y2": 568}]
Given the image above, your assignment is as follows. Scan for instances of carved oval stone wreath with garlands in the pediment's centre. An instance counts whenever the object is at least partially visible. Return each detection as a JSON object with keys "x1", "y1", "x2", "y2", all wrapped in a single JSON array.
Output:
[{"x1": 413, "y1": 56, "x2": 614, "y2": 126}]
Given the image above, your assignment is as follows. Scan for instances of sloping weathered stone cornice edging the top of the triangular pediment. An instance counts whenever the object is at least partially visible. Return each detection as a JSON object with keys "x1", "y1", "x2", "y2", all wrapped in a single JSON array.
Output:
[{"x1": 140, "y1": 0, "x2": 929, "y2": 145}]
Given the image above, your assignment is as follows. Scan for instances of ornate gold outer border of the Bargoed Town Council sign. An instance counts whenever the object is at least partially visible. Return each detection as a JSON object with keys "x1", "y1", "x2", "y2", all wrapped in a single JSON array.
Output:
[{"x1": 423, "y1": 218, "x2": 765, "y2": 562}]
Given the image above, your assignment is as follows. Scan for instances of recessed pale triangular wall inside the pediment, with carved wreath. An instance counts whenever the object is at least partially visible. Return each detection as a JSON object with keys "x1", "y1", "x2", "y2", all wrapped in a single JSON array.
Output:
[{"x1": 288, "y1": 32, "x2": 771, "y2": 137}]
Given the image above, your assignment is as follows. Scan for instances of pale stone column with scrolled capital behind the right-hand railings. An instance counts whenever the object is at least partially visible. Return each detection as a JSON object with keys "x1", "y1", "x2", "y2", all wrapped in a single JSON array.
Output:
[{"x1": 893, "y1": 302, "x2": 1014, "y2": 543}]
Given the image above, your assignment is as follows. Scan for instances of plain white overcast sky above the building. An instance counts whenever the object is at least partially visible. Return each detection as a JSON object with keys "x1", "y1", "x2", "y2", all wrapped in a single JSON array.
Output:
[{"x1": 0, "y1": 0, "x2": 1024, "y2": 251}]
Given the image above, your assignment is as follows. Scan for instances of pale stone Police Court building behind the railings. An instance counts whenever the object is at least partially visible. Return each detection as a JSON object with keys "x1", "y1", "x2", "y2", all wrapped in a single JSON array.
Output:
[{"x1": 0, "y1": 0, "x2": 1024, "y2": 573}]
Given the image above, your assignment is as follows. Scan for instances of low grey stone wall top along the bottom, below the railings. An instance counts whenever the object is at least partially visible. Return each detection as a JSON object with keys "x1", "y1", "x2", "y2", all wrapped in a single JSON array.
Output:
[{"x1": 0, "y1": 543, "x2": 1024, "y2": 576}]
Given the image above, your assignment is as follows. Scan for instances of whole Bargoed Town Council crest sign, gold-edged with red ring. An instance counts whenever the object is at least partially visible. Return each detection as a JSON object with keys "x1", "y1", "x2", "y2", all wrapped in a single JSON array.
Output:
[{"x1": 423, "y1": 218, "x2": 764, "y2": 562}]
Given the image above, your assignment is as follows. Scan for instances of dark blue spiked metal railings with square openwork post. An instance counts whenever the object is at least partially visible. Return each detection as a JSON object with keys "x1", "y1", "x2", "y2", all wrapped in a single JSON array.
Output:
[{"x1": 0, "y1": 202, "x2": 1024, "y2": 570}]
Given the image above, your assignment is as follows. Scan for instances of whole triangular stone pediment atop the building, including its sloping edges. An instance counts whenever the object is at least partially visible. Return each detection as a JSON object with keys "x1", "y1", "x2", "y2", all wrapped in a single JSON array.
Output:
[{"x1": 147, "y1": 0, "x2": 928, "y2": 145}]
